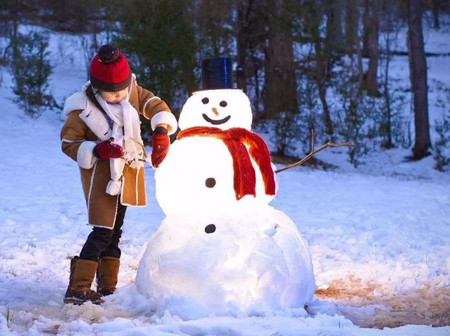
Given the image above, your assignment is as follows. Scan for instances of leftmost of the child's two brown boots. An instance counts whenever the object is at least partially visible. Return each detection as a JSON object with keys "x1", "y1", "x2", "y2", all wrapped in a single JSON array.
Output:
[{"x1": 64, "y1": 257, "x2": 104, "y2": 305}]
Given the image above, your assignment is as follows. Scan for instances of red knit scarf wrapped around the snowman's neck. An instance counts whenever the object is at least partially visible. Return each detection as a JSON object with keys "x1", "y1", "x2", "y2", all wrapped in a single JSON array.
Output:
[{"x1": 177, "y1": 126, "x2": 275, "y2": 200}]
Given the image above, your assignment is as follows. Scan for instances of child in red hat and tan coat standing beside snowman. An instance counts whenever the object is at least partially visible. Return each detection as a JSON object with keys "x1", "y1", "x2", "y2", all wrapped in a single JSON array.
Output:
[{"x1": 61, "y1": 45, "x2": 177, "y2": 304}]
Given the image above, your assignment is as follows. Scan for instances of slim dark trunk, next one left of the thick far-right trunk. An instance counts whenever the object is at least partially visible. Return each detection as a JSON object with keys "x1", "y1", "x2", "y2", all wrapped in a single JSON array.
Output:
[{"x1": 365, "y1": 0, "x2": 380, "y2": 97}]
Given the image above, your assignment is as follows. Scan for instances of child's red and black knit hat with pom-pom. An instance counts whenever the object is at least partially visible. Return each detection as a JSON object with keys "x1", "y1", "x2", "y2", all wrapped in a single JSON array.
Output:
[{"x1": 89, "y1": 44, "x2": 131, "y2": 92}]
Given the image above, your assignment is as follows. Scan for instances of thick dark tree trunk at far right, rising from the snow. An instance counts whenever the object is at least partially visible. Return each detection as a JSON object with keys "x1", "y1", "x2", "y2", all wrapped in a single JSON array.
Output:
[{"x1": 407, "y1": 0, "x2": 431, "y2": 160}]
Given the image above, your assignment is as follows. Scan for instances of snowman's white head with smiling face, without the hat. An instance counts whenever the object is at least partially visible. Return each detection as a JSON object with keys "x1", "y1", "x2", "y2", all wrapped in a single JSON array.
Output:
[{"x1": 178, "y1": 89, "x2": 253, "y2": 130}]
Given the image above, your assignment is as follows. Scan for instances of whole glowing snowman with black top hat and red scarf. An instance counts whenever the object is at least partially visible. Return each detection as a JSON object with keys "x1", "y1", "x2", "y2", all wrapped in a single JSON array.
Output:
[{"x1": 136, "y1": 58, "x2": 315, "y2": 316}]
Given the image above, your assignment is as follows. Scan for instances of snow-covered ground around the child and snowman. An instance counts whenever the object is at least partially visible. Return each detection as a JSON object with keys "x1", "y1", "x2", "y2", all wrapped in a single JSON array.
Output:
[{"x1": 0, "y1": 19, "x2": 450, "y2": 336}]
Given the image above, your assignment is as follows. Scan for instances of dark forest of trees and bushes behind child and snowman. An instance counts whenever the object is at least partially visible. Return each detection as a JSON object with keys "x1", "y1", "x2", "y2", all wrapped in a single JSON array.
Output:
[{"x1": 0, "y1": 0, "x2": 450, "y2": 171}]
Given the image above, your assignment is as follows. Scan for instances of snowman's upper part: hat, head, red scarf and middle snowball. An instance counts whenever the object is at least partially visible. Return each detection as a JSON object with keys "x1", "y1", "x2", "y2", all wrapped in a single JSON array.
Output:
[{"x1": 155, "y1": 58, "x2": 276, "y2": 215}]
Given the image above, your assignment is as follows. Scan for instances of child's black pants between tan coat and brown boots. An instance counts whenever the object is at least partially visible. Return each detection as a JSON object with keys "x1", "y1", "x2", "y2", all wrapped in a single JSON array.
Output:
[{"x1": 79, "y1": 202, "x2": 127, "y2": 261}]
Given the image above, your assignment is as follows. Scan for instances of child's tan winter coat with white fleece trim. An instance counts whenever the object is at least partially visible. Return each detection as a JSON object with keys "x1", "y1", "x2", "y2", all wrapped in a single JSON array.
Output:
[{"x1": 61, "y1": 77, "x2": 177, "y2": 229}]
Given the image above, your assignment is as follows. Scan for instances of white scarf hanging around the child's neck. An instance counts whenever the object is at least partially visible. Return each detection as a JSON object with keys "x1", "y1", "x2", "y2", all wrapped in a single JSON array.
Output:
[{"x1": 96, "y1": 92, "x2": 144, "y2": 196}]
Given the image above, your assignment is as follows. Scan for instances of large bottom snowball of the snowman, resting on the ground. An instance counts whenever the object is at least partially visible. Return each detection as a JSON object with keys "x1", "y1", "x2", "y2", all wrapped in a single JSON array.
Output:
[{"x1": 136, "y1": 206, "x2": 316, "y2": 315}]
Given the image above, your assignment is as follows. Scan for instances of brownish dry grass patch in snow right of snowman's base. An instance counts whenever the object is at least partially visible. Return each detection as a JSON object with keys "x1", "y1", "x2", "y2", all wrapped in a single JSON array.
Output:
[{"x1": 316, "y1": 277, "x2": 450, "y2": 329}]
